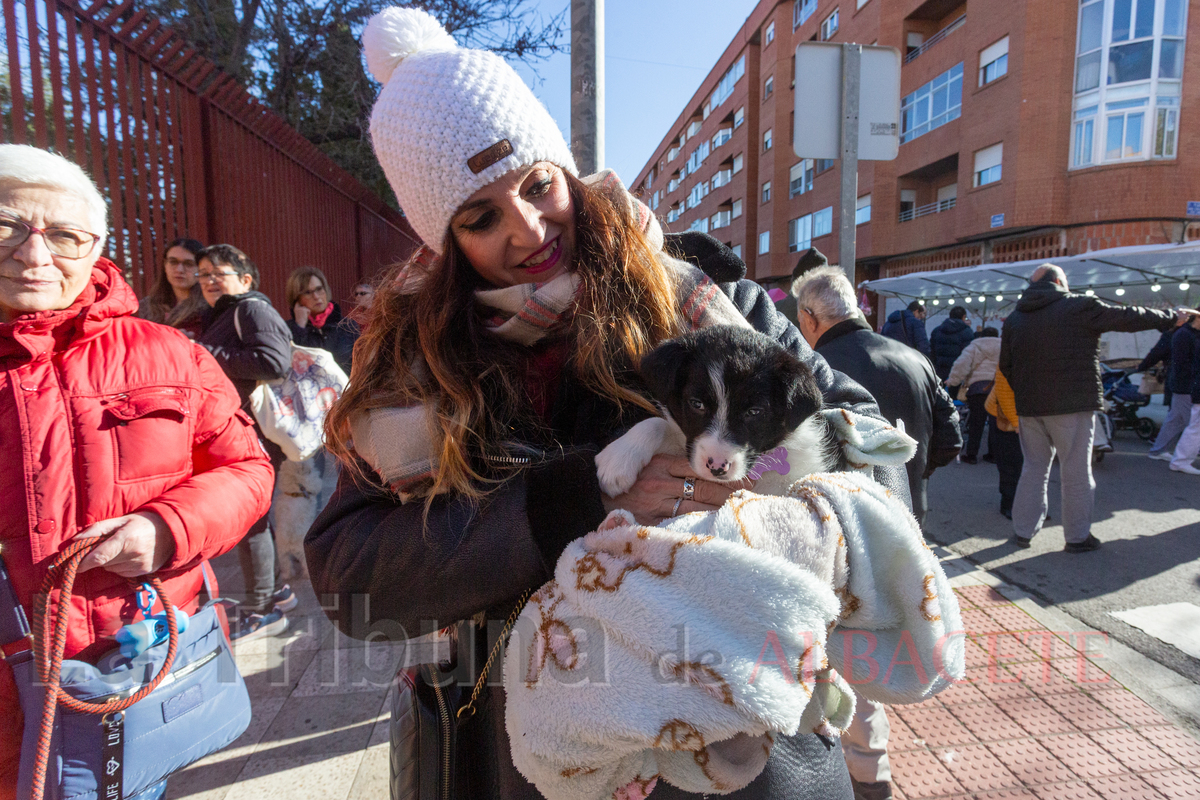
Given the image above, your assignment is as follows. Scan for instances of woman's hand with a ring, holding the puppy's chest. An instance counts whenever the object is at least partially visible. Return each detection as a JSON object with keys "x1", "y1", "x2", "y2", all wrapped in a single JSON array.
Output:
[{"x1": 602, "y1": 453, "x2": 754, "y2": 525}]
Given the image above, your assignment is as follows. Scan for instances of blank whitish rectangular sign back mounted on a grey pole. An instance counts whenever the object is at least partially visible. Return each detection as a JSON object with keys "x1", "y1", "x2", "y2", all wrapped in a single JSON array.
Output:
[{"x1": 792, "y1": 42, "x2": 900, "y2": 161}]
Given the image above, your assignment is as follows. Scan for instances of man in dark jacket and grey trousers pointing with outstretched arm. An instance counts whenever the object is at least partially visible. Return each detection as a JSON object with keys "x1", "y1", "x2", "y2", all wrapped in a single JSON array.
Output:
[{"x1": 1000, "y1": 264, "x2": 1186, "y2": 553}]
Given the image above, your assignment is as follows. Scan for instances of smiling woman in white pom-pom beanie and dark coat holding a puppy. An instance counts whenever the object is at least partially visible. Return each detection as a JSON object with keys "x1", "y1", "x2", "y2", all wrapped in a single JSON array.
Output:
[{"x1": 306, "y1": 8, "x2": 904, "y2": 800}]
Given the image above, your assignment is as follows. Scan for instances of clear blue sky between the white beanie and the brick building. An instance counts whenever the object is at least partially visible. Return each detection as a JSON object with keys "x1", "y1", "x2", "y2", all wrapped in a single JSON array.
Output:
[{"x1": 514, "y1": 0, "x2": 757, "y2": 184}]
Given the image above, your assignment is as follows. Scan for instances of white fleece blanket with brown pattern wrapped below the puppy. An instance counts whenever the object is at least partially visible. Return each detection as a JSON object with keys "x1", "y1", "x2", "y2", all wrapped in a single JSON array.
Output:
[{"x1": 504, "y1": 472, "x2": 964, "y2": 800}]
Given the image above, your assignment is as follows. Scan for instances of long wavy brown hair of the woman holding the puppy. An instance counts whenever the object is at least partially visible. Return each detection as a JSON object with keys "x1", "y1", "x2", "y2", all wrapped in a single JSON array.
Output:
[{"x1": 325, "y1": 174, "x2": 683, "y2": 499}]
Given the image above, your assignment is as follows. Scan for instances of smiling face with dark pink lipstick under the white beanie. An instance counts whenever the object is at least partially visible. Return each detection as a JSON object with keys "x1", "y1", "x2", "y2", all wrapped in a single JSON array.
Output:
[{"x1": 450, "y1": 161, "x2": 575, "y2": 287}]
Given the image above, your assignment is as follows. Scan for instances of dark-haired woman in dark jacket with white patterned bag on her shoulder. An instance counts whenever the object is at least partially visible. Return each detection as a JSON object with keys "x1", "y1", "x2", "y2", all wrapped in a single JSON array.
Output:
[{"x1": 198, "y1": 245, "x2": 295, "y2": 639}]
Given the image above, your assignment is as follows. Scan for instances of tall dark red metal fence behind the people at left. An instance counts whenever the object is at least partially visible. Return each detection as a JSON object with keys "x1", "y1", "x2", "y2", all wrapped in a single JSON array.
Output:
[{"x1": 0, "y1": 0, "x2": 419, "y2": 311}]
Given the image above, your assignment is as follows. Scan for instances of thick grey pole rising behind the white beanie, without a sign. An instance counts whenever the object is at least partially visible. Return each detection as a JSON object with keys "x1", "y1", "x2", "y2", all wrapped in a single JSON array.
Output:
[{"x1": 571, "y1": 0, "x2": 604, "y2": 175}]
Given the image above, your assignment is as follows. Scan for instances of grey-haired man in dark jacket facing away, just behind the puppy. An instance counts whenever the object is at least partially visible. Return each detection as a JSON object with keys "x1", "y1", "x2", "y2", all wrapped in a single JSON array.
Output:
[{"x1": 792, "y1": 261, "x2": 962, "y2": 800}]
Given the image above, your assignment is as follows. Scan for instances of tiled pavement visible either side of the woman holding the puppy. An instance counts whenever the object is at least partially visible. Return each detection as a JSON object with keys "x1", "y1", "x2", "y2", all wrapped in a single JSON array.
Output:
[{"x1": 167, "y1": 554, "x2": 1200, "y2": 800}]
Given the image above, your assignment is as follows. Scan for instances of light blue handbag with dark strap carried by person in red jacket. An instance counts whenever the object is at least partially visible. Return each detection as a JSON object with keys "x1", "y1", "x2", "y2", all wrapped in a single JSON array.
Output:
[{"x1": 0, "y1": 547, "x2": 251, "y2": 800}]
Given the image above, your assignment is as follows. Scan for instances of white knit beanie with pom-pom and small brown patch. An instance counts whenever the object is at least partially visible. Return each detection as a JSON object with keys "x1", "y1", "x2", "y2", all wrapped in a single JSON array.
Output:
[{"x1": 362, "y1": 7, "x2": 576, "y2": 253}]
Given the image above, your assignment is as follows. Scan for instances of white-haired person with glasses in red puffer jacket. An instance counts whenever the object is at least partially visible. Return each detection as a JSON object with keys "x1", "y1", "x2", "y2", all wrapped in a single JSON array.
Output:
[{"x1": 0, "y1": 144, "x2": 272, "y2": 800}]
